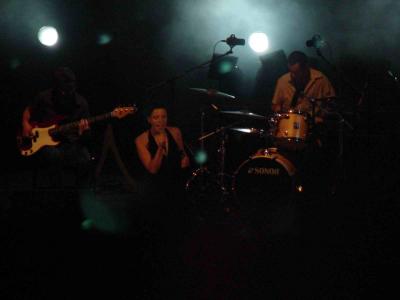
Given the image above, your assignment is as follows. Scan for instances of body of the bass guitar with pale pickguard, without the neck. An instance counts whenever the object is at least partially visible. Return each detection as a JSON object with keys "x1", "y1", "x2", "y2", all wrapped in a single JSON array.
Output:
[{"x1": 18, "y1": 124, "x2": 60, "y2": 156}]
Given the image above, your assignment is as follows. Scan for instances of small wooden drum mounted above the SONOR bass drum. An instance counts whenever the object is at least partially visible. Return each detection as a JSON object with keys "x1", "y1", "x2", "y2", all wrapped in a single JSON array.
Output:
[{"x1": 274, "y1": 110, "x2": 308, "y2": 150}]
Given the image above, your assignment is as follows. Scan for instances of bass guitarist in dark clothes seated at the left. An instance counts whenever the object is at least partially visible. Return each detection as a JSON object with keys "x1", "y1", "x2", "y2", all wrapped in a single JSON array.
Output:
[{"x1": 22, "y1": 67, "x2": 90, "y2": 187}]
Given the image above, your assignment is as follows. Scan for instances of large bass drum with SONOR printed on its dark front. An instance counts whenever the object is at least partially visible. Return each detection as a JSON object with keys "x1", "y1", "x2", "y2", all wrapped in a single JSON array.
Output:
[{"x1": 232, "y1": 149, "x2": 296, "y2": 229}]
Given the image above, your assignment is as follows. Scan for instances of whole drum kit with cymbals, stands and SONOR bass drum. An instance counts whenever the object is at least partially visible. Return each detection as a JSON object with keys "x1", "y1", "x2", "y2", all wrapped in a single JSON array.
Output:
[{"x1": 186, "y1": 89, "x2": 340, "y2": 218}]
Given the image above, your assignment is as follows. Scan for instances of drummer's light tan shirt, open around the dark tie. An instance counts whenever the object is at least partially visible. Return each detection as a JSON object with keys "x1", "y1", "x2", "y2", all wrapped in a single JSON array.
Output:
[{"x1": 272, "y1": 68, "x2": 335, "y2": 114}]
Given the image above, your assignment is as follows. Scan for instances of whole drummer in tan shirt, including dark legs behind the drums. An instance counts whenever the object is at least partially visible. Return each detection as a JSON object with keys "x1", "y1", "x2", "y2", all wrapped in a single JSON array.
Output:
[{"x1": 271, "y1": 51, "x2": 335, "y2": 195}]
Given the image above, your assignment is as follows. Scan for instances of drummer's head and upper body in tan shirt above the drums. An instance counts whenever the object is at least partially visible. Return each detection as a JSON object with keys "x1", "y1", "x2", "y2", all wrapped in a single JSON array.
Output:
[{"x1": 272, "y1": 51, "x2": 335, "y2": 123}]
